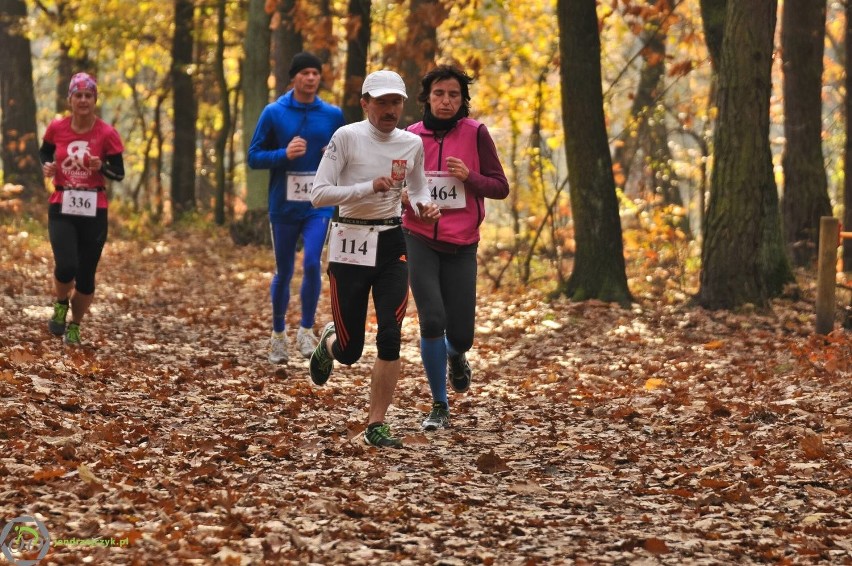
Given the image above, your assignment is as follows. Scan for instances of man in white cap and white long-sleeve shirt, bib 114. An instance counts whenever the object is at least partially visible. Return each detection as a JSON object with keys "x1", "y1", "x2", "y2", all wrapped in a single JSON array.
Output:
[{"x1": 310, "y1": 71, "x2": 441, "y2": 448}]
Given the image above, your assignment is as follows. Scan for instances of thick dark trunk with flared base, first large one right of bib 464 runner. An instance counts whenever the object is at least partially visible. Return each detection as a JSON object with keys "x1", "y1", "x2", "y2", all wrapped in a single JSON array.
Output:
[{"x1": 557, "y1": 0, "x2": 632, "y2": 305}]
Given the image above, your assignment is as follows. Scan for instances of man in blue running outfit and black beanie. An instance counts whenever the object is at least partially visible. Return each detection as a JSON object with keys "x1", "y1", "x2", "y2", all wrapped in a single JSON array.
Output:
[{"x1": 248, "y1": 53, "x2": 344, "y2": 364}]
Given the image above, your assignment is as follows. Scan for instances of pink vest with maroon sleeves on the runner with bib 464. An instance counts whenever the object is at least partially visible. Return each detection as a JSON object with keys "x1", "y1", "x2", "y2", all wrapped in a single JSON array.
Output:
[{"x1": 402, "y1": 118, "x2": 509, "y2": 246}]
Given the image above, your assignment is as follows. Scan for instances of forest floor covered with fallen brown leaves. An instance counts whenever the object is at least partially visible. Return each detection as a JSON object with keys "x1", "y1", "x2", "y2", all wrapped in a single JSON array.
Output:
[{"x1": 0, "y1": 230, "x2": 852, "y2": 565}]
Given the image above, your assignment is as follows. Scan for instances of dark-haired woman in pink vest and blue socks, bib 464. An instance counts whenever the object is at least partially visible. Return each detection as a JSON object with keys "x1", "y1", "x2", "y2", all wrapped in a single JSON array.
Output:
[{"x1": 402, "y1": 65, "x2": 509, "y2": 430}]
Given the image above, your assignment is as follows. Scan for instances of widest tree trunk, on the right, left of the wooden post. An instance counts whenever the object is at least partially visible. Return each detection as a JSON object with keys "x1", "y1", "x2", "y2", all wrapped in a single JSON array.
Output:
[{"x1": 698, "y1": 0, "x2": 793, "y2": 309}]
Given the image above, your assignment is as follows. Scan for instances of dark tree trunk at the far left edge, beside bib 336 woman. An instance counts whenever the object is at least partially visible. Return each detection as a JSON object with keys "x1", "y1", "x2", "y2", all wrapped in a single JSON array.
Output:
[{"x1": 0, "y1": 0, "x2": 44, "y2": 201}]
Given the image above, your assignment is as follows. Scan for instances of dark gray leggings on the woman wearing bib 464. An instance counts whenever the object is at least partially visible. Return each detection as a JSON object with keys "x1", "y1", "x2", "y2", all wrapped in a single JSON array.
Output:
[{"x1": 405, "y1": 233, "x2": 478, "y2": 352}]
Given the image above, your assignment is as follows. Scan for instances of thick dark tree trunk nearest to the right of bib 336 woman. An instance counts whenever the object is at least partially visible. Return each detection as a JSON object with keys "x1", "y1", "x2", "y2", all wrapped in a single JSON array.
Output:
[{"x1": 171, "y1": 0, "x2": 198, "y2": 218}]
